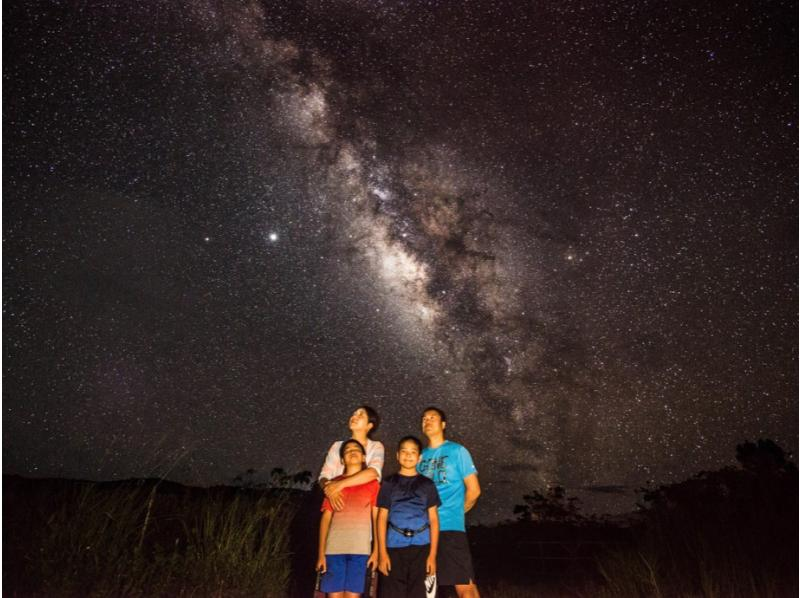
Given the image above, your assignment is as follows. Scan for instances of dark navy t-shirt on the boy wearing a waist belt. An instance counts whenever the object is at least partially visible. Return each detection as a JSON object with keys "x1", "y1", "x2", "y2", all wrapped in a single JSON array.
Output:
[{"x1": 378, "y1": 473, "x2": 440, "y2": 548}]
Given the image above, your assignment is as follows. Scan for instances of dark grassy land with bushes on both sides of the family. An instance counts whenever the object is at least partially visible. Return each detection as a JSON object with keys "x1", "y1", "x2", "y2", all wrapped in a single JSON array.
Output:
[{"x1": 3, "y1": 454, "x2": 798, "y2": 598}]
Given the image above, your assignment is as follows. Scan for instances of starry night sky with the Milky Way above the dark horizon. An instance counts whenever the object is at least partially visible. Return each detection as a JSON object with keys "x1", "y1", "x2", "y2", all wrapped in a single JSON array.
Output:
[{"x1": 3, "y1": 0, "x2": 798, "y2": 521}]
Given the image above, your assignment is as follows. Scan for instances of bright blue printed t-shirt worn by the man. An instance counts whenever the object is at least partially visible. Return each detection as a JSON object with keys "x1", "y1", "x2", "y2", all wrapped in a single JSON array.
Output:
[{"x1": 417, "y1": 440, "x2": 478, "y2": 532}]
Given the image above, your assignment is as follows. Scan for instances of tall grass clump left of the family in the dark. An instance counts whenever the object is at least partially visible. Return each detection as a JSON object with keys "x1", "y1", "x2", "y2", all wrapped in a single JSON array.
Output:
[{"x1": 26, "y1": 485, "x2": 293, "y2": 598}]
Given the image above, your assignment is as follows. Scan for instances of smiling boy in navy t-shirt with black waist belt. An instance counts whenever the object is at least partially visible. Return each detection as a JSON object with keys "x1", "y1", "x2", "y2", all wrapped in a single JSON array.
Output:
[{"x1": 378, "y1": 436, "x2": 440, "y2": 598}]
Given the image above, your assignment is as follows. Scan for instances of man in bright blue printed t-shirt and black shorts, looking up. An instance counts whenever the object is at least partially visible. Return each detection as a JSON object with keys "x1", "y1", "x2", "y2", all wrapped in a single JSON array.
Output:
[{"x1": 417, "y1": 407, "x2": 481, "y2": 598}]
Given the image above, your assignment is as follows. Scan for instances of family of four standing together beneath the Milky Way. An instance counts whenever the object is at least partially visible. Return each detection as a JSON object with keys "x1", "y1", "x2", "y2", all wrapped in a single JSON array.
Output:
[{"x1": 317, "y1": 405, "x2": 481, "y2": 598}]
